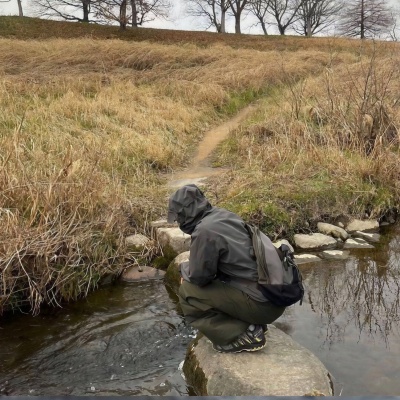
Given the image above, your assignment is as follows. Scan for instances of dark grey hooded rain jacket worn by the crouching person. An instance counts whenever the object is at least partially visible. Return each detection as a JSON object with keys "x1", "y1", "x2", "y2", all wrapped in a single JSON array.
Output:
[{"x1": 168, "y1": 185, "x2": 268, "y2": 302}]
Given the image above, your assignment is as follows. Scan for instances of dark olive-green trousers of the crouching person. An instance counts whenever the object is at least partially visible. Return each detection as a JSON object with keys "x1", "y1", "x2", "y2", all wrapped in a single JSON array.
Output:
[{"x1": 178, "y1": 279, "x2": 285, "y2": 345}]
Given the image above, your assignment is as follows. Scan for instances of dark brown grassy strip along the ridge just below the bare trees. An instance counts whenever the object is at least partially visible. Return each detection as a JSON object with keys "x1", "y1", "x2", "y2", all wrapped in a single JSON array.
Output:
[{"x1": 0, "y1": 16, "x2": 397, "y2": 52}]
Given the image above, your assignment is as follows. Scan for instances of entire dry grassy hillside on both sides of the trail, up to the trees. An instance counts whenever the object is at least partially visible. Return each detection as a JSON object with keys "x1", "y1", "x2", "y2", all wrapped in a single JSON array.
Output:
[{"x1": 0, "y1": 17, "x2": 400, "y2": 312}]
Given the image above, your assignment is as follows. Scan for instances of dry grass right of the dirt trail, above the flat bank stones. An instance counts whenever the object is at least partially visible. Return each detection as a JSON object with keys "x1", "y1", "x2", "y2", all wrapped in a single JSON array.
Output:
[{"x1": 214, "y1": 50, "x2": 400, "y2": 237}]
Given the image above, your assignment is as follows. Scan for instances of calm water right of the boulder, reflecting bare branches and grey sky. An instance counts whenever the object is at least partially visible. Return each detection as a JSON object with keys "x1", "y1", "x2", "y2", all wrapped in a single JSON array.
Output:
[{"x1": 278, "y1": 225, "x2": 400, "y2": 395}]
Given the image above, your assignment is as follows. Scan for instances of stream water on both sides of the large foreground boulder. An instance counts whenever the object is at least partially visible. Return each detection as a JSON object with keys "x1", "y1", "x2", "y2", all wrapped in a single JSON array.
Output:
[{"x1": 0, "y1": 223, "x2": 400, "y2": 396}]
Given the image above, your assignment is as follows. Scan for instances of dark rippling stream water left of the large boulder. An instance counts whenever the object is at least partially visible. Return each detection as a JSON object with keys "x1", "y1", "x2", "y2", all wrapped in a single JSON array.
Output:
[{"x1": 0, "y1": 282, "x2": 193, "y2": 395}]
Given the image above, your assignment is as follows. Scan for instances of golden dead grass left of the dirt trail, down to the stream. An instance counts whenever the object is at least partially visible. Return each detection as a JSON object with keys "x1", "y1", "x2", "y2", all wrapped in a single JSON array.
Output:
[{"x1": 0, "y1": 35, "x2": 382, "y2": 313}]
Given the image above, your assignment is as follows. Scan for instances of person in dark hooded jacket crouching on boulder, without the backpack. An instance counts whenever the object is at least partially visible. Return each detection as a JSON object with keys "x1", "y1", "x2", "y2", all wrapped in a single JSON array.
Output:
[{"x1": 168, "y1": 185, "x2": 285, "y2": 353}]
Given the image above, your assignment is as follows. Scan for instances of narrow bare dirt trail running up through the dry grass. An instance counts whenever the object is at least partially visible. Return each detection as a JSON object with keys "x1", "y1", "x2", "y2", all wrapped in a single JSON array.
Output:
[{"x1": 168, "y1": 104, "x2": 254, "y2": 188}]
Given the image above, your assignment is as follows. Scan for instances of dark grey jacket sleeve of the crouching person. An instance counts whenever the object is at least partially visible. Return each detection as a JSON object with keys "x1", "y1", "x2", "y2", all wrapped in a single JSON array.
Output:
[{"x1": 181, "y1": 229, "x2": 221, "y2": 286}]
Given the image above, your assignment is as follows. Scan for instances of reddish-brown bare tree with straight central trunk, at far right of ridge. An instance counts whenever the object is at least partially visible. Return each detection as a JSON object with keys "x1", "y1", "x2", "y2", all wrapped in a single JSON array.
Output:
[{"x1": 339, "y1": 0, "x2": 395, "y2": 39}]
